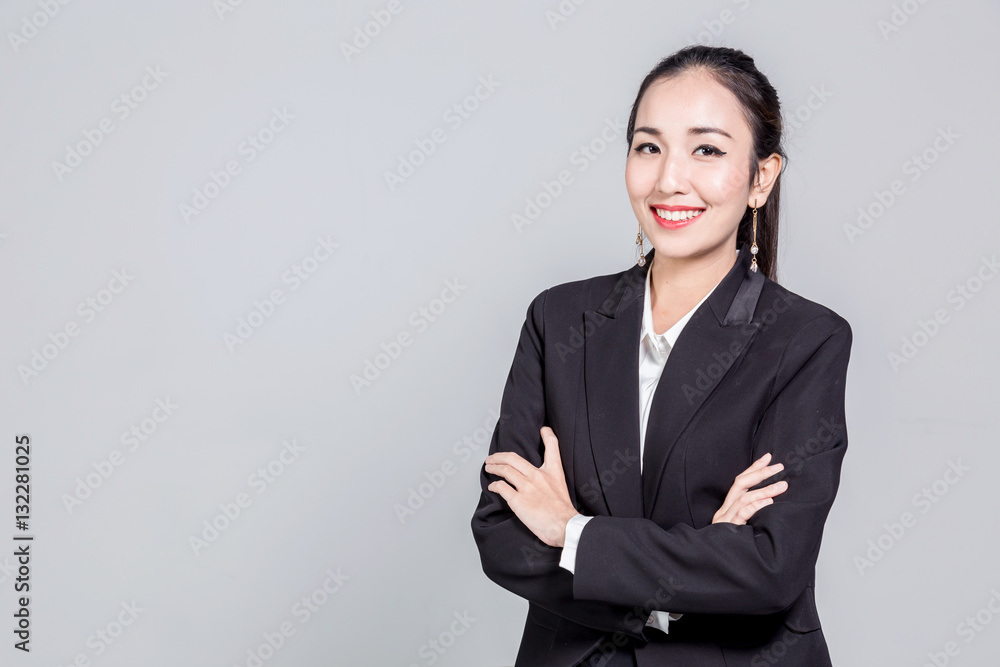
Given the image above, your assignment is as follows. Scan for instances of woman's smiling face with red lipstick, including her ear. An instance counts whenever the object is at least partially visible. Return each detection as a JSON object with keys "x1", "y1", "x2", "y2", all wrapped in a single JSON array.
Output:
[{"x1": 625, "y1": 70, "x2": 766, "y2": 259}]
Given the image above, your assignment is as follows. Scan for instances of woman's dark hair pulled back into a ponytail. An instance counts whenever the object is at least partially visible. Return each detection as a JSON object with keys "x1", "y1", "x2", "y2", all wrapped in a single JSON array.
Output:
[{"x1": 625, "y1": 44, "x2": 788, "y2": 280}]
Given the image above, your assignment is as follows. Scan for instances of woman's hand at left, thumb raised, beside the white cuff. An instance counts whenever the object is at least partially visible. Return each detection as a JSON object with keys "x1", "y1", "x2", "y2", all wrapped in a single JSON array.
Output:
[{"x1": 486, "y1": 426, "x2": 578, "y2": 547}]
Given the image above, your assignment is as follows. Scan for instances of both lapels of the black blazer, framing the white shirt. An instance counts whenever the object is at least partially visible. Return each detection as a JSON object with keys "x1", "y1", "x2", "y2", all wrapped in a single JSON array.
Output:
[{"x1": 584, "y1": 244, "x2": 764, "y2": 518}]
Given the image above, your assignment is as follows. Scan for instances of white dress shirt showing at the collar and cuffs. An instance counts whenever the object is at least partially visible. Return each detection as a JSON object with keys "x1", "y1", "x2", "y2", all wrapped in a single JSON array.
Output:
[{"x1": 559, "y1": 260, "x2": 722, "y2": 632}]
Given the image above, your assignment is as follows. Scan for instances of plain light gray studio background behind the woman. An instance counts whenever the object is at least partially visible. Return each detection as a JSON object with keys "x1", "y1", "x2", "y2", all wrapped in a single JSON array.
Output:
[{"x1": 0, "y1": 0, "x2": 1000, "y2": 667}]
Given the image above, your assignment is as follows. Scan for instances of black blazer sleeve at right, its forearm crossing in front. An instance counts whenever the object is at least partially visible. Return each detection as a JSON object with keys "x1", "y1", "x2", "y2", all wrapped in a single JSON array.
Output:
[{"x1": 573, "y1": 311, "x2": 852, "y2": 614}]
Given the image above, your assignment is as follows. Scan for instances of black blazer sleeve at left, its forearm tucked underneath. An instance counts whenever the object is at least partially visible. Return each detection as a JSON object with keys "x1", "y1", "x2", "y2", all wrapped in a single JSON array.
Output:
[{"x1": 472, "y1": 290, "x2": 649, "y2": 640}]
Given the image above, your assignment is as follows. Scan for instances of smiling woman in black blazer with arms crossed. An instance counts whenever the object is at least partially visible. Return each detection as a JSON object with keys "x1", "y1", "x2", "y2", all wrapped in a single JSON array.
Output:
[{"x1": 472, "y1": 46, "x2": 852, "y2": 667}]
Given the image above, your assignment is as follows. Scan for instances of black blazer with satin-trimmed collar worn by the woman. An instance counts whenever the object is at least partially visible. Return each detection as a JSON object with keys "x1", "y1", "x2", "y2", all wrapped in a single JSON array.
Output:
[{"x1": 472, "y1": 245, "x2": 852, "y2": 667}]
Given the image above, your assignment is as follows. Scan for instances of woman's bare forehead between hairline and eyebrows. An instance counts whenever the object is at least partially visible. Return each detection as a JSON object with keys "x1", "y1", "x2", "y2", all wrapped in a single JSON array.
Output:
[{"x1": 635, "y1": 70, "x2": 750, "y2": 142}]
